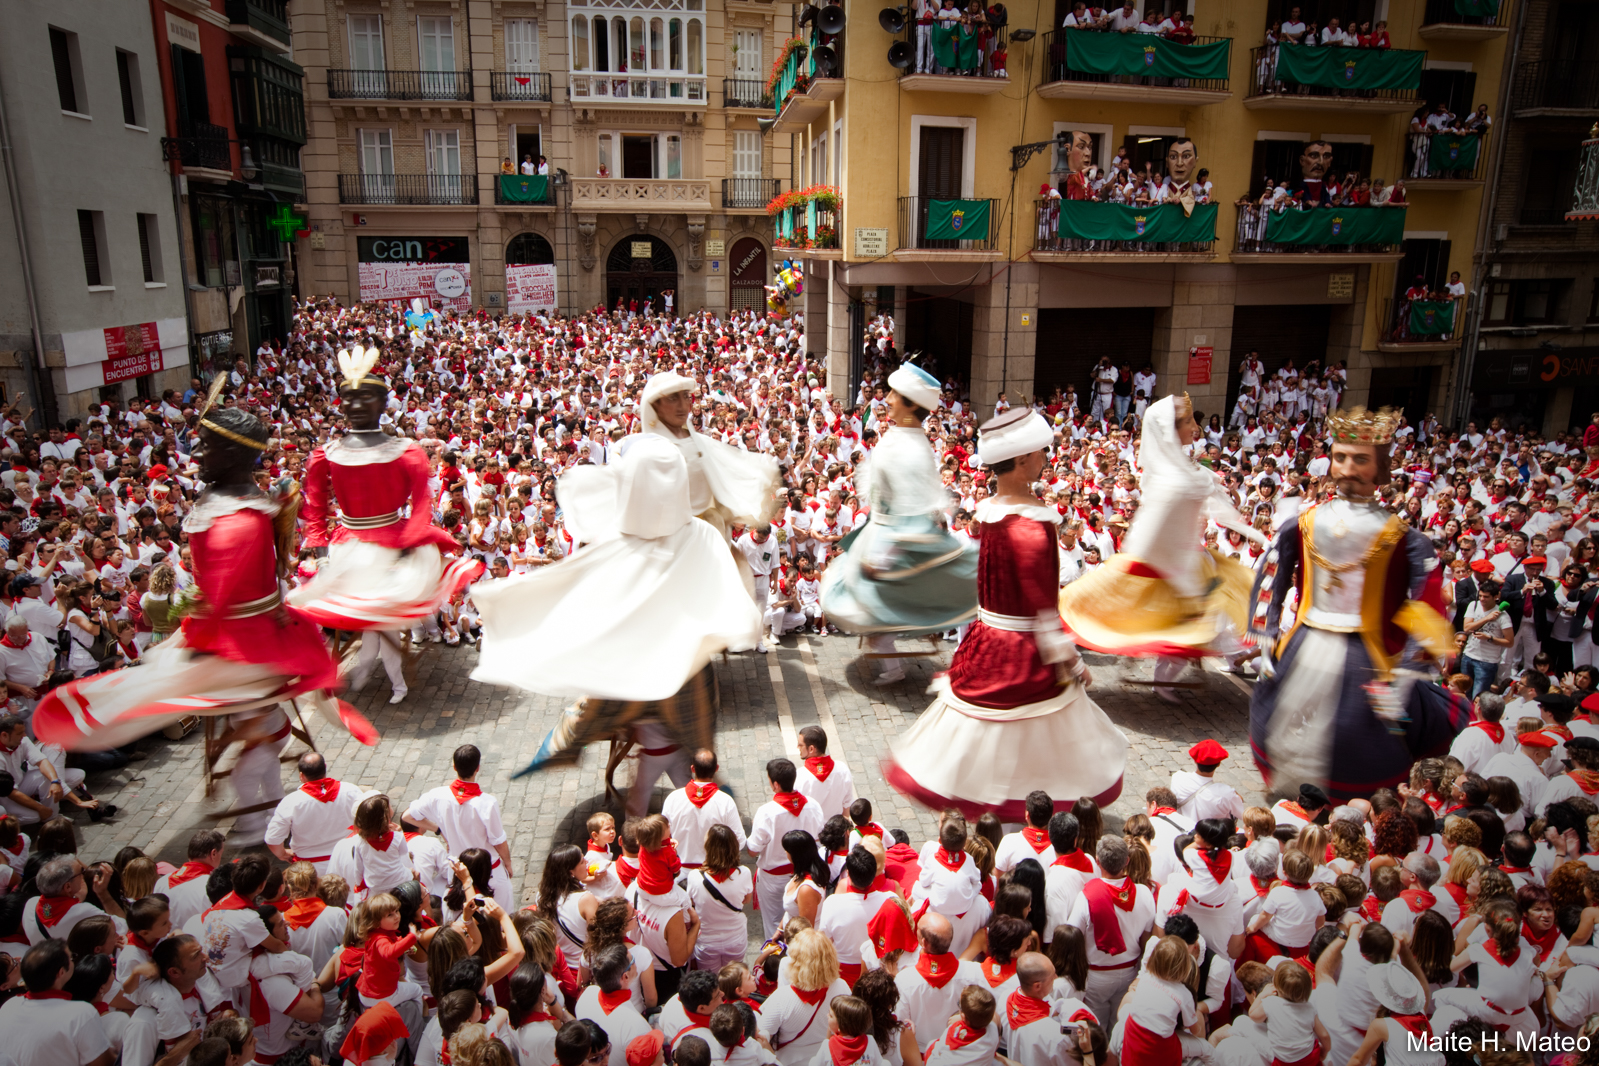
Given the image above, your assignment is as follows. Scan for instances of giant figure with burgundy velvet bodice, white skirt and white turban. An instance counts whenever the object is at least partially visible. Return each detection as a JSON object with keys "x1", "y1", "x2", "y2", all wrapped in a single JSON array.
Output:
[{"x1": 884, "y1": 409, "x2": 1127, "y2": 821}]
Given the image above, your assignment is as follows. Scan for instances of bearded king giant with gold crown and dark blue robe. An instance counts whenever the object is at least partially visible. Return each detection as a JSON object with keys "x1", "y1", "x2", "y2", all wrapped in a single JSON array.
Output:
[{"x1": 1249, "y1": 408, "x2": 1471, "y2": 799}]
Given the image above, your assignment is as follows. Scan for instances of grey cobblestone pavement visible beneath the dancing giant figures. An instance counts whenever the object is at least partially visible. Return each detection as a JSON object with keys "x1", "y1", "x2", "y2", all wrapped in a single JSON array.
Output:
[{"x1": 62, "y1": 636, "x2": 1263, "y2": 900}]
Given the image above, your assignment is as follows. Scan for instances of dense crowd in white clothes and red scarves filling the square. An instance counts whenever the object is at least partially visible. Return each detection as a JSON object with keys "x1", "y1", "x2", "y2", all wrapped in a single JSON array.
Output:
[{"x1": 0, "y1": 299, "x2": 1599, "y2": 1066}]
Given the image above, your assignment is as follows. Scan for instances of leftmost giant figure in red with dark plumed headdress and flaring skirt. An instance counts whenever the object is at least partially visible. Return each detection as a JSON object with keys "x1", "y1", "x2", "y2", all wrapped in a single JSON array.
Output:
[{"x1": 34, "y1": 408, "x2": 377, "y2": 751}]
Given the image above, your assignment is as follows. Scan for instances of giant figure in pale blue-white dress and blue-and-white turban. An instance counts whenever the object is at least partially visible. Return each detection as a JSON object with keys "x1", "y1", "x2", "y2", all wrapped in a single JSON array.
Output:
[{"x1": 822, "y1": 363, "x2": 977, "y2": 684}]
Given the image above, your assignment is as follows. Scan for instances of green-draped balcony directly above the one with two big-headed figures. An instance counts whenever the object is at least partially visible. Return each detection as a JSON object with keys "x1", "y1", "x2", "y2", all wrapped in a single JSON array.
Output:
[{"x1": 1038, "y1": 30, "x2": 1233, "y2": 105}]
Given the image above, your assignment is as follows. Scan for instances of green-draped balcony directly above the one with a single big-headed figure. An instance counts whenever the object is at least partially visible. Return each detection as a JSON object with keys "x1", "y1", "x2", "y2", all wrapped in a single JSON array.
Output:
[{"x1": 1244, "y1": 45, "x2": 1426, "y2": 115}]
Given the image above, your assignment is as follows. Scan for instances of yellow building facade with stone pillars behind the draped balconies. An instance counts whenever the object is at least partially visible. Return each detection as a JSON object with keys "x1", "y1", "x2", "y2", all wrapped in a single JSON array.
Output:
[{"x1": 786, "y1": 0, "x2": 1513, "y2": 417}]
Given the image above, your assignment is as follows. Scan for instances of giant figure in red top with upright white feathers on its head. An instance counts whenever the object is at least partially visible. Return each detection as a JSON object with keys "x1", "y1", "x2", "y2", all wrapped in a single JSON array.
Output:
[{"x1": 289, "y1": 348, "x2": 483, "y2": 703}]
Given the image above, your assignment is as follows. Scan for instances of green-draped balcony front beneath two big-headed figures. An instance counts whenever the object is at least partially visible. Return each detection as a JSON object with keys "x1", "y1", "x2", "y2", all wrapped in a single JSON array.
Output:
[{"x1": 1033, "y1": 198, "x2": 1218, "y2": 262}]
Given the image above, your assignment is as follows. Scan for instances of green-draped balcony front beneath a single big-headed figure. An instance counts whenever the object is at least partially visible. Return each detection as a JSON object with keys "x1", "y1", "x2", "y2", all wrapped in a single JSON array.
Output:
[{"x1": 1231, "y1": 205, "x2": 1406, "y2": 262}]
